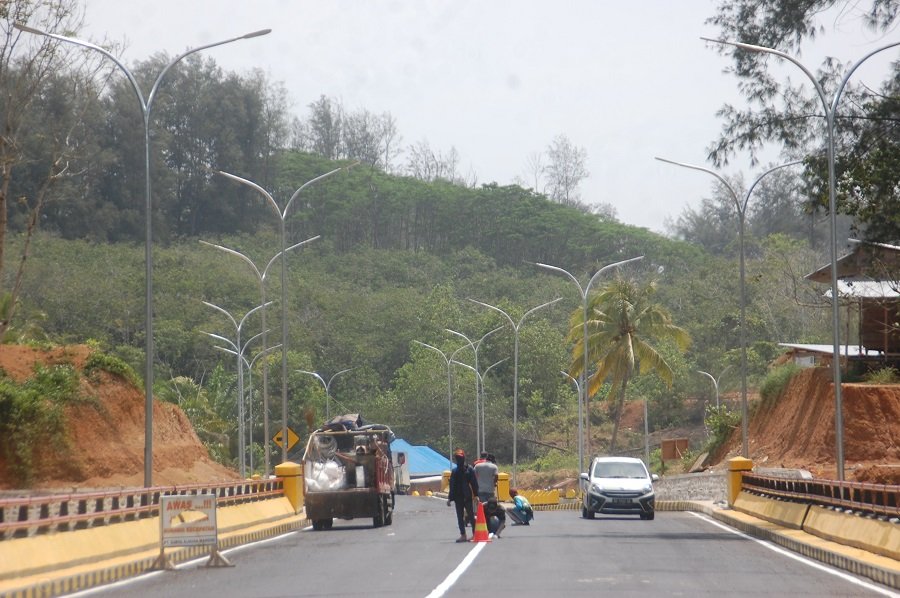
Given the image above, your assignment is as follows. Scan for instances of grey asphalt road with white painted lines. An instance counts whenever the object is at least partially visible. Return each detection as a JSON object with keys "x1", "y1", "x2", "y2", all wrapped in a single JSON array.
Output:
[{"x1": 79, "y1": 496, "x2": 897, "y2": 598}]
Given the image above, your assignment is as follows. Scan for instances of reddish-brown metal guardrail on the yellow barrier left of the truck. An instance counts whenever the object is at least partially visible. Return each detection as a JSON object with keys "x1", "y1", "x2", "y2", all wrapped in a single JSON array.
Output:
[{"x1": 0, "y1": 478, "x2": 284, "y2": 540}]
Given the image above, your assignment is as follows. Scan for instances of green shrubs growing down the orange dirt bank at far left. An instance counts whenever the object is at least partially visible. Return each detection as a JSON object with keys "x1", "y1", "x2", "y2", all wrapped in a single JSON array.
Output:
[{"x1": 0, "y1": 365, "x2": 82, "y2": 485}]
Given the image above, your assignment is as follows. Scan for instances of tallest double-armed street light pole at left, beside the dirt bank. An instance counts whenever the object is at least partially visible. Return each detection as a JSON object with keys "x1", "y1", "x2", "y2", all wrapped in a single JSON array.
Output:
[{"x1": 14, "y1": 23, "x2": 272, "y2": 488}]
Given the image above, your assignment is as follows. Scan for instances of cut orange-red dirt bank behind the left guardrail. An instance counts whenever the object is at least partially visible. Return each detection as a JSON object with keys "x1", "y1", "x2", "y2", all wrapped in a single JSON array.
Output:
[{"x1": 0, "y1": 345, "x2": 238, "y2": 491}]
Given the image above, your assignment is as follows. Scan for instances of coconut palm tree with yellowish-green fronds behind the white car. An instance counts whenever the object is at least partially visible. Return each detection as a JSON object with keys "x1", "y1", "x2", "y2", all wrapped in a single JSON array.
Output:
[{"x1": 568, "y1": 278, "x2": 690, "y2": 452}]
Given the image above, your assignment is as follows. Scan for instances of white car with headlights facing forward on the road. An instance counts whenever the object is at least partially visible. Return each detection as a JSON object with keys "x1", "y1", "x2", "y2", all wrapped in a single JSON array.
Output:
[{"x1": 581, "y1": 457, "x2": 659, "y2": 519}]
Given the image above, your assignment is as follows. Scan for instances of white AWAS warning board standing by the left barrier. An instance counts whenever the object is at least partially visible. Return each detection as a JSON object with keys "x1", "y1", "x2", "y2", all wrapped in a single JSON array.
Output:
[{"x1": 159, "y1": 494, "x2": 218, "y2": 548}]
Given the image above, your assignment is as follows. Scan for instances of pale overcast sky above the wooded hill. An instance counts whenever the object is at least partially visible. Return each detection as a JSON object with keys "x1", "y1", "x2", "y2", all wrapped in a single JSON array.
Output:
[{"x1": 80, "y1": 0, "x2": 898, "y2": 232}]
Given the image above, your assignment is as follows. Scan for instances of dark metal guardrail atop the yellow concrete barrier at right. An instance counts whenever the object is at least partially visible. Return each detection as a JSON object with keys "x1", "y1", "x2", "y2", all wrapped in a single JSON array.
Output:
[{"x1": 741, "y1": 473, "x2": 900, "y2": 517}]
